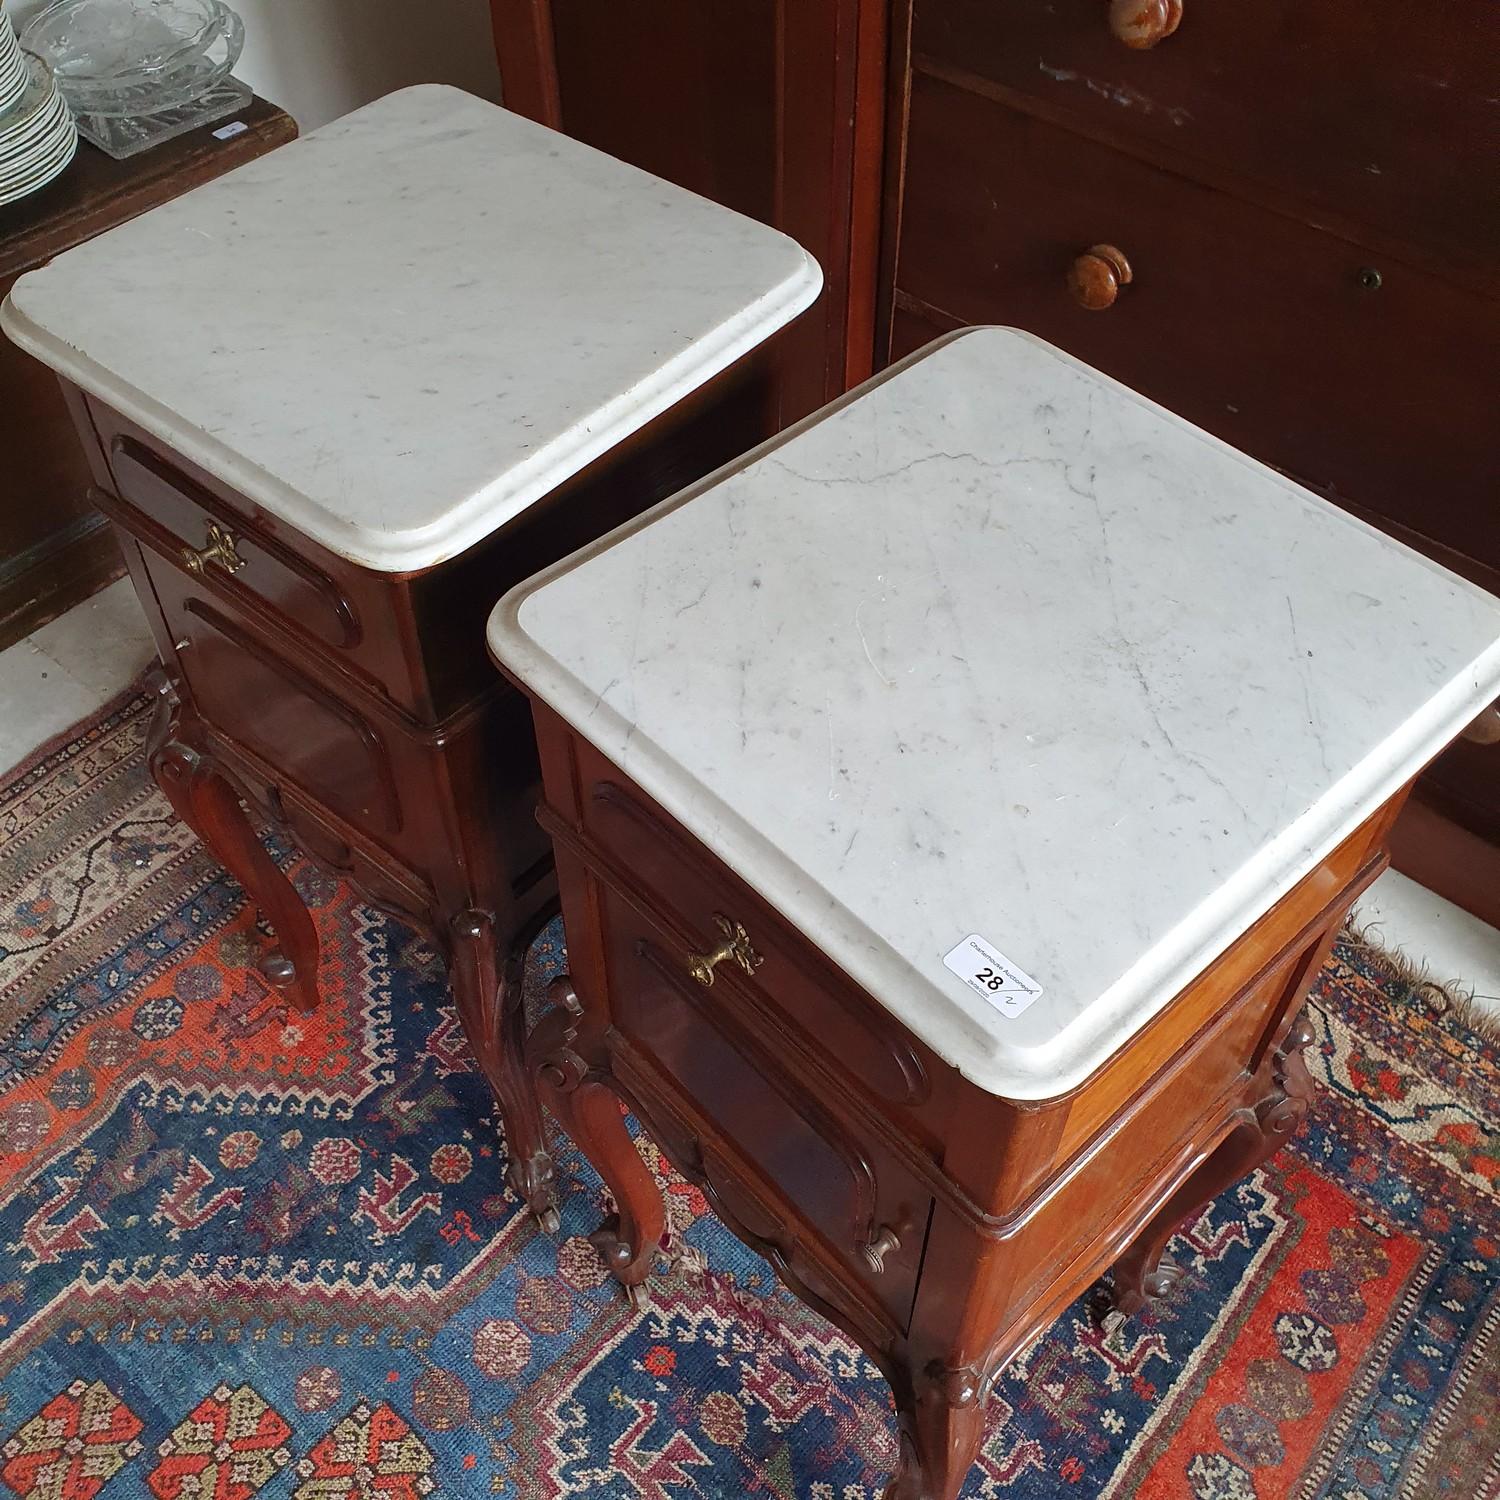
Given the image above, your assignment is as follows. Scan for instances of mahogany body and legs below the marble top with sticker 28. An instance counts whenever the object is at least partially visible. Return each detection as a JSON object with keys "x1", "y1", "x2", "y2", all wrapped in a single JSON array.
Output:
[{"x1": 528, "y1": 705, "x2": 1406, "y2": 1500}]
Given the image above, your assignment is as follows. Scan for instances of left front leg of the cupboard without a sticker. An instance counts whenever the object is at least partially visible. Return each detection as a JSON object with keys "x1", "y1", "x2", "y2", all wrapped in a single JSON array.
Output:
[{"x1": 146, "y1": 684, "x2": 318, "y2": 1011}]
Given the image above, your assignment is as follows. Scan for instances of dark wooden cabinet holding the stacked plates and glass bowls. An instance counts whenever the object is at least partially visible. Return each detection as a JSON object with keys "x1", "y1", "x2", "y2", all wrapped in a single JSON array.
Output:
[{"x1": 0, "y1": 99, "x2": 297, "y2": 648}]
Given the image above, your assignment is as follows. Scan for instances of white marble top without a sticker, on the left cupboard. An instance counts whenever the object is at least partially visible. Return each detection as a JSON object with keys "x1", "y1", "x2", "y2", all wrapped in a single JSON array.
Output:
[{"x1": 0, "y1": 86, "x2": 822, "y2": 572}]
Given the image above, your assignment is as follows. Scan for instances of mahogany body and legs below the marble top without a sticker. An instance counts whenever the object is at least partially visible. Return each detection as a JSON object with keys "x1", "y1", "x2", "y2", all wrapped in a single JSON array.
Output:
[{"x1": 65, "y1": 360, "x2": 768, "y2": 1221}]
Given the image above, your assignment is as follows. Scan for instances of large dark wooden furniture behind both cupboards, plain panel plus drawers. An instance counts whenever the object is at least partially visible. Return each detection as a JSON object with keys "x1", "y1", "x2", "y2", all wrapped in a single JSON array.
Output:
[{"x1": 492, "y1": 0, "x2": 1500, "y2": 924}]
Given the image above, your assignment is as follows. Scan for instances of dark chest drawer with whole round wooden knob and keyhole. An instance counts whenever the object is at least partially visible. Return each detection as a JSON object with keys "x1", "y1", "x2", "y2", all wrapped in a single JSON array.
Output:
[{"x1": 897, "y1": 73, "x2": 1500, "y2": 570}]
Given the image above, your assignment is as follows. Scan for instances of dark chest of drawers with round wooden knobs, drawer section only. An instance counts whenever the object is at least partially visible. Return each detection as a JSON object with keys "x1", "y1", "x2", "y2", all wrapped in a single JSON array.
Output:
[{"x1": 878, "y1": 0, "x2": 1500, "y2": 926}]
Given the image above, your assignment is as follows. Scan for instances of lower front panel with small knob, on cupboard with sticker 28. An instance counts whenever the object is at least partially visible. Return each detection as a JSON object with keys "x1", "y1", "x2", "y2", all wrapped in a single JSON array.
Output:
[{"x1": 602, "y1": 890, "x2": 933, "y2": 1331}]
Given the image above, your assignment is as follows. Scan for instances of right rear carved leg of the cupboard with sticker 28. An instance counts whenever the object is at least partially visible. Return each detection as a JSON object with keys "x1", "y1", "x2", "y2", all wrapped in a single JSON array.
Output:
[{"x1": 1106, "y1": 1014, "x2": 1313, "y2": 1328}]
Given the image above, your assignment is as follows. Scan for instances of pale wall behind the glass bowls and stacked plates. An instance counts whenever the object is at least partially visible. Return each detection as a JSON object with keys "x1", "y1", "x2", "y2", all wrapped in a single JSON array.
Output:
[{"x1": 6, "y1": 0, "x2": 500, "y2": 132}]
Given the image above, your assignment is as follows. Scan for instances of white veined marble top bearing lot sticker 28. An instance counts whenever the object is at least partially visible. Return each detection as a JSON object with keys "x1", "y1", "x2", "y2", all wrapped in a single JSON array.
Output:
[{"x1": 489, "y1": 329, "x2": 1500, "y2": 1098}]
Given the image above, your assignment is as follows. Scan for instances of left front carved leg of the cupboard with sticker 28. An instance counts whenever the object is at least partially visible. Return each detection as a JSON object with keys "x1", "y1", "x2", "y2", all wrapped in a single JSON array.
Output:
[{"x1": 528, "y1": 975, "x2": 666, "y2": 1307}]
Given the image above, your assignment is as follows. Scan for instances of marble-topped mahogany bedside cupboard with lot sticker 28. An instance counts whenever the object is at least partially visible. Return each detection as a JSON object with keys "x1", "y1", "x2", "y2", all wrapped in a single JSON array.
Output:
[{"x1": 489, "y1": 329, "x2": 1500, "y2": 1500}]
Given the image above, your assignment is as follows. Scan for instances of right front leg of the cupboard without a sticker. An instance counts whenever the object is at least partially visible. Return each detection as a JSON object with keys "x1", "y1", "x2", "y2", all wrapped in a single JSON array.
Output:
[{"x1": 449, "y1": 911, "x2": 560, "y2": 1235}]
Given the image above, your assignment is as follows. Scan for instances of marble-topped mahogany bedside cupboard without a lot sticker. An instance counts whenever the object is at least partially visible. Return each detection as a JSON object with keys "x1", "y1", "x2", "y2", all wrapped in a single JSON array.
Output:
[{"x1": 0, "y1": 87, "x2": 821, "y2": 1221}]
